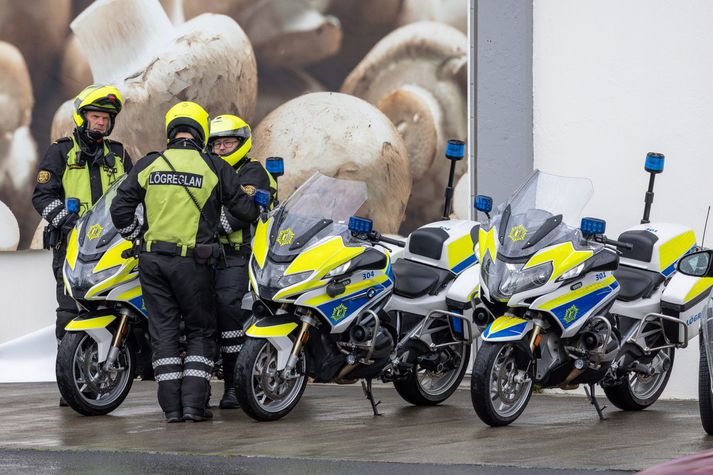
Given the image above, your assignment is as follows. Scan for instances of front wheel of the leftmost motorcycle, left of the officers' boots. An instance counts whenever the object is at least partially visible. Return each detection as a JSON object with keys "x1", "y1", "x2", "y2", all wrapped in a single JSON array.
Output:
[{"x1": 55, "y1": 332, "x2": 135, "y2": 416}]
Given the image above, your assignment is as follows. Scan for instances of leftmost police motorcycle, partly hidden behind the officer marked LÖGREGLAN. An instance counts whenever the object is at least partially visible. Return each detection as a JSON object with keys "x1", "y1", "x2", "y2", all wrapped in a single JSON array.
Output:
[{"x1": 56, "y1": 178, "x2": 150, "y2": 416}]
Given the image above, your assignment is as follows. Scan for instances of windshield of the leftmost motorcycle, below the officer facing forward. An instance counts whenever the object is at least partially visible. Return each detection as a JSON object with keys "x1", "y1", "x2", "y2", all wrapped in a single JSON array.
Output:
[{"x1": 75, "y1": 175, "x2": 143, "y2": 261}]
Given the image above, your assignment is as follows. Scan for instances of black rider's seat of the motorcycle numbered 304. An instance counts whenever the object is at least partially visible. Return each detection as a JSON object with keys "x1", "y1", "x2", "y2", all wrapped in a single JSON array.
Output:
[{"x1": 392, "y1": 259, "x2": 453, "y2": 298}]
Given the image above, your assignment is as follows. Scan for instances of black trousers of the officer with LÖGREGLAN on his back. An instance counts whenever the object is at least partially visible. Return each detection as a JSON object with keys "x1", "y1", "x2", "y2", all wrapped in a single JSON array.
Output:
[{"x1": 139, "y1": 253, "x2": 216, "y2": 412}]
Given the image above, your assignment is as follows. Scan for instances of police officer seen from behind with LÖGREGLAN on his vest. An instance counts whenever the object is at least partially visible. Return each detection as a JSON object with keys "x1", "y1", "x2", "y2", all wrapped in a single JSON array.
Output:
[{"x1": 111, "y1": 102, "x2": 259, "y2": 422}]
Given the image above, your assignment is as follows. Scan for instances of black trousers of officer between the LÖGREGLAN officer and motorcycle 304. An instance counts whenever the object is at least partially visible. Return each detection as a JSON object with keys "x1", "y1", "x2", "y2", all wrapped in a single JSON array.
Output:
[{"x1": 215, "y1": 256, "x2": 250, "y2": 386}]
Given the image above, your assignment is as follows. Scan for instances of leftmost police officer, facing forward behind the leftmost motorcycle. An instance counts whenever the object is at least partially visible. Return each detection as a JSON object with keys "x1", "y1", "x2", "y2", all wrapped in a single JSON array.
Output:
[{"x1": 32, "y1": 85, "x2": 132, "y2": 346}]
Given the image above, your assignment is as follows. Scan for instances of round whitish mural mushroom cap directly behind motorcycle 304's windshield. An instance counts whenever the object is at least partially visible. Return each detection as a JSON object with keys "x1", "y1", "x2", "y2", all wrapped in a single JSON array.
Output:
[{"x1": 252, "y1": 92, "x2": 411, "y2": 233}]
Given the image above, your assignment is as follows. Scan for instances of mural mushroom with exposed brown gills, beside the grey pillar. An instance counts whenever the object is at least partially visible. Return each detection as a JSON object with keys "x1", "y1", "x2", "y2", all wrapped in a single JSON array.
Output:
[{"x1": 342, "y1": 22, "x2": 468, "y2": 233}]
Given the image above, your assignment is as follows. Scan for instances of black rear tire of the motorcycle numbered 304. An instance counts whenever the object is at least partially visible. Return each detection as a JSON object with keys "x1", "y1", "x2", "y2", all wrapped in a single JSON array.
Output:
[{"x1": 394, "y1": 344, "x2": 470, "y2": 406}]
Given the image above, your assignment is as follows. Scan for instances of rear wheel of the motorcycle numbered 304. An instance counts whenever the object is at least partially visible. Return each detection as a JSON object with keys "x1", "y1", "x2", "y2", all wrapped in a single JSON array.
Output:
[{"x1": 394, "y1": 343, "x2": 470, "y2": 406}]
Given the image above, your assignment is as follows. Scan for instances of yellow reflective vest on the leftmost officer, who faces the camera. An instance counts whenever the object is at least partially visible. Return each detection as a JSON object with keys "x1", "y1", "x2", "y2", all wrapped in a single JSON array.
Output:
[{"x1": 62, "y1": 135, "x2": 125, "y2": 216}]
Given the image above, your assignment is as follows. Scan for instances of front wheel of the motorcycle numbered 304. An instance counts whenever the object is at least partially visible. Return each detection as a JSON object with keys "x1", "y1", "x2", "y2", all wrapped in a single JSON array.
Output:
[{"x1": 235, "y1": 338, "x2": 307, "y2": 421}]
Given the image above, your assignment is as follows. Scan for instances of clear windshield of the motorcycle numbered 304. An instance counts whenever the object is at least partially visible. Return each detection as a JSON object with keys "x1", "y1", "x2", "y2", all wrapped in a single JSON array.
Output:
[{"x1": 270, "y1": 173, "x2": 367, "y2": 262}]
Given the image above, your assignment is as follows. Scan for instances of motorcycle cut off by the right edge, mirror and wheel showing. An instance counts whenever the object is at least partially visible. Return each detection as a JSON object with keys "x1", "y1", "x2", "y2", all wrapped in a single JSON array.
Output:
[{"x1": 677, "y1": 253, "x2": 713, "y2": 434}]
